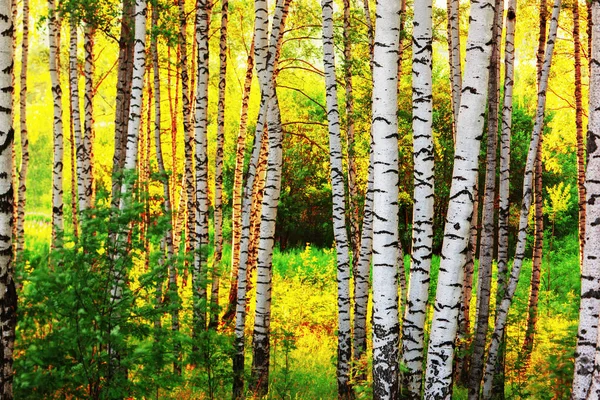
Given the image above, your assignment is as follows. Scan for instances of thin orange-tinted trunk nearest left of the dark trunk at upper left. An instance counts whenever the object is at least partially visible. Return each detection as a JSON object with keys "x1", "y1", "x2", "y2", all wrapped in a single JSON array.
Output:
[{"x1": 82, "y1": 25, "x2": 95, "y2": 208}]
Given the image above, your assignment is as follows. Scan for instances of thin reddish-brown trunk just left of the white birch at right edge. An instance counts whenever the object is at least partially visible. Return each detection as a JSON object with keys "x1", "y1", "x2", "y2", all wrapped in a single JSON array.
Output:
[{"x1": 573, "y1": 1, "x2": 586, "y2": 265}]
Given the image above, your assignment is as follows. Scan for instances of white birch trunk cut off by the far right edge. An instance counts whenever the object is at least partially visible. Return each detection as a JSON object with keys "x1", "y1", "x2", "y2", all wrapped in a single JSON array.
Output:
[{"x1": 571, "y1": 0, "x2": 600, "y2": 400}]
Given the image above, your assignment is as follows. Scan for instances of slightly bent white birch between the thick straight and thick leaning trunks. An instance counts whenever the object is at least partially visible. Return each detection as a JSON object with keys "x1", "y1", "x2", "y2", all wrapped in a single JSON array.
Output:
[{"x1": 400, "y1": 0, "x2": 434, "y2": 399}]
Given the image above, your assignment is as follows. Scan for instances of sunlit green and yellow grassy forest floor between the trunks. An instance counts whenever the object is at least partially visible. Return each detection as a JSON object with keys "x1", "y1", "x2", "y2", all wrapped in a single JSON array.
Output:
[{"x1": 16, "y1": 215, "x2": 579, "y2": 399}]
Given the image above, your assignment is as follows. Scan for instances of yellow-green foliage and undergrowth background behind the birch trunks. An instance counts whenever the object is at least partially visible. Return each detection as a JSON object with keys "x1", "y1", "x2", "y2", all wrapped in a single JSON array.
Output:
[{"x1": 2, "y1": 0, "x2": 589, "y2": 398}]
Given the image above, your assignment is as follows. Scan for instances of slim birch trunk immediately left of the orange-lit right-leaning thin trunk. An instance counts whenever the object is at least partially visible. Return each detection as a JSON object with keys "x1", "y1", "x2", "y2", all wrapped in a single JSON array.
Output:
[{"x1": 210, "y1": 0, "x2": 229, "y2": 328}]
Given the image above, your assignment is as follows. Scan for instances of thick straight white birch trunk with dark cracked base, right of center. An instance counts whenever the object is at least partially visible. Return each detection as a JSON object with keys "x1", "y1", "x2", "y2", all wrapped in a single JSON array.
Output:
[{"x1": 372, "y1": 0, "x2": 400, "y2": 399}]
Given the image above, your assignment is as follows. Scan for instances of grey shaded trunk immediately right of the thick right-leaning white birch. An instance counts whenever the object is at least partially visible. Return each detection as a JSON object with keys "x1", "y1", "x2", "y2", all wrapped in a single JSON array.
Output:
[{"x1": 469, "y1": 0, "x2": 504, "y2": 400}]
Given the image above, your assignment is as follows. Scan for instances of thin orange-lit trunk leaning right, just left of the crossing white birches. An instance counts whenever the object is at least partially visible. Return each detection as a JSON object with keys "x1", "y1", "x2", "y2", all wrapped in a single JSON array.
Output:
[{"x1": 223, "y1": 40, "x2": 254, "y2": 321}]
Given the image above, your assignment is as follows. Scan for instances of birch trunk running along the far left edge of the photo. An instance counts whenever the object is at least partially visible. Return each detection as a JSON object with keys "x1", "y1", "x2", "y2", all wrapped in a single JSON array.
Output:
[{"x1": 0, "y1": 0, "x2": 17, "y2": 400}]
